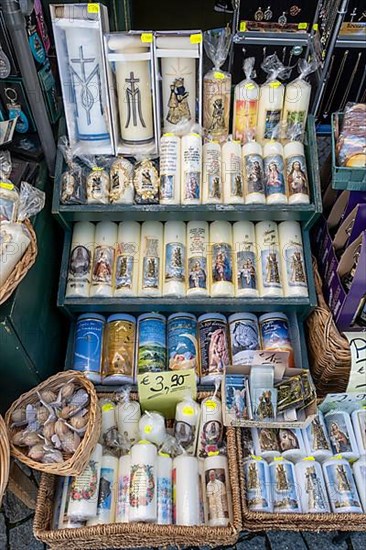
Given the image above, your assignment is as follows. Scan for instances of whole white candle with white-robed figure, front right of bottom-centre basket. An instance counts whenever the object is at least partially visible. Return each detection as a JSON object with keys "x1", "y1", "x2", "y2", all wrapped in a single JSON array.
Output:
[{"x1": 204, "y1": 456, "x2": 233, "y2": 527}]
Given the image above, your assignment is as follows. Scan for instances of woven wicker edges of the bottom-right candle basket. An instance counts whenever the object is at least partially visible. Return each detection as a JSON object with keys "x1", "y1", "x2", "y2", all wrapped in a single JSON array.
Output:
[{"x1": 236, "y1": 428, "x2": 366, "y2": 532}]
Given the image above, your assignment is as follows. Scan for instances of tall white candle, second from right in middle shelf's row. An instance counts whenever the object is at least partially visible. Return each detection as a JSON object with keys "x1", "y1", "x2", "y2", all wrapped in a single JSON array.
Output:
[{"x1": 255, "y1": 221, "x2": 283, "y2": 297}]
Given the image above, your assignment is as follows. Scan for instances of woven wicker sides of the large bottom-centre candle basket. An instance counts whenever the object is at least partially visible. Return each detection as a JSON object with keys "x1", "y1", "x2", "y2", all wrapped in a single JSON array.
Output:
[{"x1": 33, "y1": 393, "x2": 241, "y2": 550}]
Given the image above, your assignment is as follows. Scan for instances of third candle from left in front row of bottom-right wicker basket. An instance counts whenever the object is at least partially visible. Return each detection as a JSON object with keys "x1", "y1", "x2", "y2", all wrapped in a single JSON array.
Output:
[{"x1": 295, "y1": 457, "x2": 330, "y2": 514}]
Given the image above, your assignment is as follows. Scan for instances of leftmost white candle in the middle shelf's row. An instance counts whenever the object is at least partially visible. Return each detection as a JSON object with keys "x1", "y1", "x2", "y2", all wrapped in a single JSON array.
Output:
[{"x1": 66, "y1": 222, "x2": 95, "y2": 298}]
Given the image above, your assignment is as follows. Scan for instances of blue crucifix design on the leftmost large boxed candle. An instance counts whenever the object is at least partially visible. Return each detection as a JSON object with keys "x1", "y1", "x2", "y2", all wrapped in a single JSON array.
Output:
[{"x1": 70, "y1": 46, "x2": 103, "y2": 126}]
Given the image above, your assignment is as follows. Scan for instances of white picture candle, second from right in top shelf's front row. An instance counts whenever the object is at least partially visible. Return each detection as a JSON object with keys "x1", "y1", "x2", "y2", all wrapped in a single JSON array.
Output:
[{"x1": 263, "y1": 141, "x2": 287, "y2": 204}]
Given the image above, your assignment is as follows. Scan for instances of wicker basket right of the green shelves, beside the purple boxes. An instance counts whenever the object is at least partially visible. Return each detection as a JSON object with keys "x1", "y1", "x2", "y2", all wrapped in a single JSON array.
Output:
[{"x1": 306, "y1": 259, "x2": 351, "y2": 397}]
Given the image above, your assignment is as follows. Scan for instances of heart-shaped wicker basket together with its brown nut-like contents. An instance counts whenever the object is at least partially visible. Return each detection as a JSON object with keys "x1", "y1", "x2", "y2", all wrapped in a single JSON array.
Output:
[{"x1": 5, "y1": 371, "x2": 100, "y2": 476}]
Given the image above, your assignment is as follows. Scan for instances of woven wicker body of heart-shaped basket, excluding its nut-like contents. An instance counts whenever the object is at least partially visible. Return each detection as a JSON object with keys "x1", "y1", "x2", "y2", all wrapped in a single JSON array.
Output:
[{"x1": 5, "y1": 371, "x2": 101, "y2": 476}]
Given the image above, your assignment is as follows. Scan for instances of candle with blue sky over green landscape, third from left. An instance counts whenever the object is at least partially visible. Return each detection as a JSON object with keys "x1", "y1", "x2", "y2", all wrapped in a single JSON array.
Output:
[{"x1": 137, "y1": 313, "x2": 166, "y2": 374}]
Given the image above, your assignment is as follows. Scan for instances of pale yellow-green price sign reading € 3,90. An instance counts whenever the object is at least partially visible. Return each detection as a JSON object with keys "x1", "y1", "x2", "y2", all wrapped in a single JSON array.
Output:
[{"x1": 137, "y1": 369, "x2": 197, "y2": 418}]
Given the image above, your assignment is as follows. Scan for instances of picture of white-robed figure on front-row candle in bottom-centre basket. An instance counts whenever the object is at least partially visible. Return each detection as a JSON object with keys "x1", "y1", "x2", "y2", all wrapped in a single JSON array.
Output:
[{"x1": 205, "y1": 468, "x2": 230, "y2": 521}]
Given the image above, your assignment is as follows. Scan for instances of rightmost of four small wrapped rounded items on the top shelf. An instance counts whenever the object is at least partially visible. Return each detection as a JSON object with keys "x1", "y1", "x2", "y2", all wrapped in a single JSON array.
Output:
[{"x1": 133, "y1": 159, "x2": 160, "y2": 204}]
